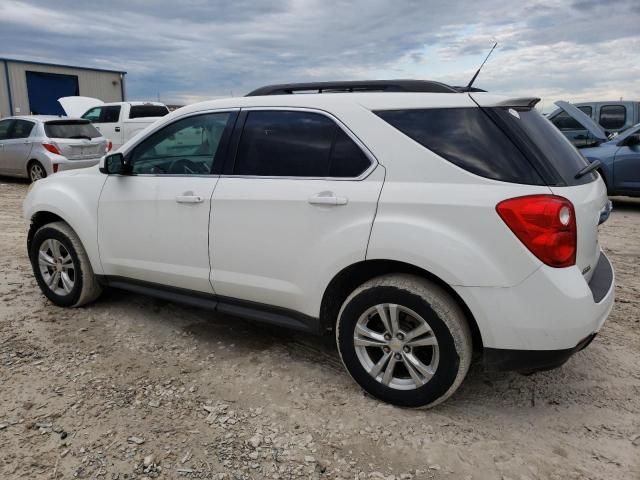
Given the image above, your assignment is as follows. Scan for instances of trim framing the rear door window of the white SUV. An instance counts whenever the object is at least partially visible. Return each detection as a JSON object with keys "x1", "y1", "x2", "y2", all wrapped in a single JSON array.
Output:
[{"x1": 221, "y1": 107, "x2": 379, "y2": 182}]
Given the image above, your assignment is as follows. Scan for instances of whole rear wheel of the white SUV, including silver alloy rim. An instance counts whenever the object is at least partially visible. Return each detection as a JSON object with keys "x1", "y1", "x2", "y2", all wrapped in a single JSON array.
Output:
[{"x1": 336, "y1": 274, "x2": 473, "y2": 407}]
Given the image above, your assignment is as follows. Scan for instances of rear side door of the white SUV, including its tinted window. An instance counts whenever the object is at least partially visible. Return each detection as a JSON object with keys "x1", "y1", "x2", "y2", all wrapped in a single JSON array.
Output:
[{"x1": 210, "y1": 109, "x2": 384, "y2": 316}]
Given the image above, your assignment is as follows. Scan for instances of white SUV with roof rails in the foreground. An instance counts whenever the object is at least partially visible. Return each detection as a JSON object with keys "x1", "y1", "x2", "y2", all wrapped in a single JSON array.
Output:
[{"x1": 24, "y1": 81, "x2": 614, "y2": 406}]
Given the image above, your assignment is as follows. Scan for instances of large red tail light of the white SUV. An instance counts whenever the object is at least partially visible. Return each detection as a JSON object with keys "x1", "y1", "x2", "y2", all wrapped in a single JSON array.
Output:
[{"x1": 496, "y1": 195, "x2": 577, "y2": 268}]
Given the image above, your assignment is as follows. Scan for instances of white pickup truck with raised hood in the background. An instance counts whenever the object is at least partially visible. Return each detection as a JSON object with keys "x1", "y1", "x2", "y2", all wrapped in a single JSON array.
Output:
[{"x1": 58, "y1": 97, "x2": 169, "y2": 151}]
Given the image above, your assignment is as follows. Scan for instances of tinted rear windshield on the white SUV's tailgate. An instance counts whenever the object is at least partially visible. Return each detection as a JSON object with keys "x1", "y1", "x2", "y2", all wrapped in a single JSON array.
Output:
[{"x1": 487, "y1": 108, "x2": 596, "y2": 185}]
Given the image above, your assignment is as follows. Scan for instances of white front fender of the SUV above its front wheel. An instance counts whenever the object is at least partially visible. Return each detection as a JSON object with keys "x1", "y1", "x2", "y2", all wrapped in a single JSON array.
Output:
[{"x1": 23, "y1": 167, "x2": 107, "y2": 275}]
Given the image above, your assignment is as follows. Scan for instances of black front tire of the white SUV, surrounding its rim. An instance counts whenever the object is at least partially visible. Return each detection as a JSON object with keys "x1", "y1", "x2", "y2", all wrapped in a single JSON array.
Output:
[{"x1": 29, "y1": 222, "x2": 102, "y2": 307}]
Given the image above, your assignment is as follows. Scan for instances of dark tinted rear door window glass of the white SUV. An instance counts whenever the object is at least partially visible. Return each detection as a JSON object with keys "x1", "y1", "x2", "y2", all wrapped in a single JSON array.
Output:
[{"x1": 234, "y1": 111, "x2": 370, "y2": 178}]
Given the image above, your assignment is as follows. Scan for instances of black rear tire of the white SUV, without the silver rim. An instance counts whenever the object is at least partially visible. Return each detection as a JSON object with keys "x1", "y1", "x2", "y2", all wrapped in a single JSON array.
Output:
[{"x1": 336, "y1": 274, "x2": 473, "y2": 407}]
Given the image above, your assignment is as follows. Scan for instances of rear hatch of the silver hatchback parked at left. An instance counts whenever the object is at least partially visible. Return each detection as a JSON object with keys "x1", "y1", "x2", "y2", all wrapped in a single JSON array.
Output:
[{"x1": 44, "y1": 119, "x2": 107, "y2": 160}]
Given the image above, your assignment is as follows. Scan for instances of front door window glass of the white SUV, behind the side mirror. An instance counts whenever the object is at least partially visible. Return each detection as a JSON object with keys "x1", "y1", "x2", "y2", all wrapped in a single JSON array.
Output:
[{"x1": 130, "y1": 112, "x2": 231, "y2": 175}]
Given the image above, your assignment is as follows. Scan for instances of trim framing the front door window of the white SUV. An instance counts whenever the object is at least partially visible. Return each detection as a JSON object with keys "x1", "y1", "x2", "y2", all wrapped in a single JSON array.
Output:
[{"x1": 118, "y1": 108, "x2": 240, "y2": 178}]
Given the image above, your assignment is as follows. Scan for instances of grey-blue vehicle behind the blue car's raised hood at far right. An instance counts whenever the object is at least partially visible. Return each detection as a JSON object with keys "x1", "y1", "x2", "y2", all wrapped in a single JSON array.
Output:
[{"x1": 547, "y1": 101, "x2": 640, "y2": 148}]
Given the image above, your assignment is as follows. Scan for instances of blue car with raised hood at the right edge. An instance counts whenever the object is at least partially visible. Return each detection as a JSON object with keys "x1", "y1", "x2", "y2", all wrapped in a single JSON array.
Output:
[{"x1": 556, "y1": 102, "x2": 640, "y2": 197}]
